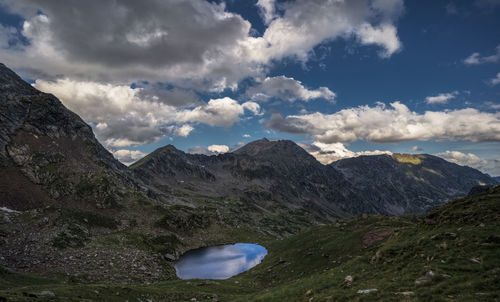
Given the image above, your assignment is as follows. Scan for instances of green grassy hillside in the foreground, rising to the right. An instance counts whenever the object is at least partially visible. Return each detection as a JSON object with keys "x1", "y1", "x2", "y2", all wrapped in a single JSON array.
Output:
[{"x1": 0, "y1": 186, "x2": 500, "y2": 301}]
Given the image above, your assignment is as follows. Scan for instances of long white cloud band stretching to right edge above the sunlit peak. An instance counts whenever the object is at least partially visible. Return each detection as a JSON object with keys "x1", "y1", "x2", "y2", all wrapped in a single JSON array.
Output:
[{"x1": 267, "y1": 102, "x2": 500, "y2": 143}]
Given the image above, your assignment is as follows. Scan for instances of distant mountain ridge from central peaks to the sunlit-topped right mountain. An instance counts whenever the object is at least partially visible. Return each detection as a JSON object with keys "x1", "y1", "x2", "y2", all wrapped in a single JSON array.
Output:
[{"x1": 131, "y1": 138, "x2": 494, "y2": 219}]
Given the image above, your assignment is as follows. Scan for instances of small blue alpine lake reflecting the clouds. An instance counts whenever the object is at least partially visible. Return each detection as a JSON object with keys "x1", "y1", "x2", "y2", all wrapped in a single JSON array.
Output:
[{"x1": 175, "y1": 243, "x2": 267, "y2": 279}]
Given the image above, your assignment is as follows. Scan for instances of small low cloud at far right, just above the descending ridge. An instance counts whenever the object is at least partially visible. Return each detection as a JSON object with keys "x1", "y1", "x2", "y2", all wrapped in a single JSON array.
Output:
[{"x1": 434, "y1": 150, "x2": 500, "y2": 175}]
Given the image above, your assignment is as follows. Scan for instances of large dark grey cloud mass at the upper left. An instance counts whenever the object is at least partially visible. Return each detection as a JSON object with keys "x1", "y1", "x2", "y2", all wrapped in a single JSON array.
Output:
[{"x1": 13, "y1": 0, "x2": 248, "y2": 68}]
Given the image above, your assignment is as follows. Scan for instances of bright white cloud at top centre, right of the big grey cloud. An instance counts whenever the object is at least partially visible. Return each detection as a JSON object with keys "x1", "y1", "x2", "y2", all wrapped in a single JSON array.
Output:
[{"x1": 240, "y1": 0, "x2": 404, "y2": 62}]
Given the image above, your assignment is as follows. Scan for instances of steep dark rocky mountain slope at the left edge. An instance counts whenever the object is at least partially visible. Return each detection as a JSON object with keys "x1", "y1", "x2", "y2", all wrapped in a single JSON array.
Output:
[{"x1": 0, "y1": 64, "x2": 132, "y2": 210}]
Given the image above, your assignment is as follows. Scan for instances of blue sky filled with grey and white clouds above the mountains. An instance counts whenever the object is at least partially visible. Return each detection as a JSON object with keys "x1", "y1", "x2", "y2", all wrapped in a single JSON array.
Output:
[{"x1": 0, "y1": 0, "x2": 500, "y2": 176}]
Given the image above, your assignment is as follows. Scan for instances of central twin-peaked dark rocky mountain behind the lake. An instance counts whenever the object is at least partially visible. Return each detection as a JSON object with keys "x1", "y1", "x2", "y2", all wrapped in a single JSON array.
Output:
[{"x1": 130, "y1": 139, "x2": 354, "y2": 233}]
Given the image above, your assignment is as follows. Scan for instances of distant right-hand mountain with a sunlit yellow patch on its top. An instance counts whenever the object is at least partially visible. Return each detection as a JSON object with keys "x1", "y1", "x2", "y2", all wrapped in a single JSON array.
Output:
[{"x1": 330, "y1": 154, "x2": 495, "y2": 215}]
